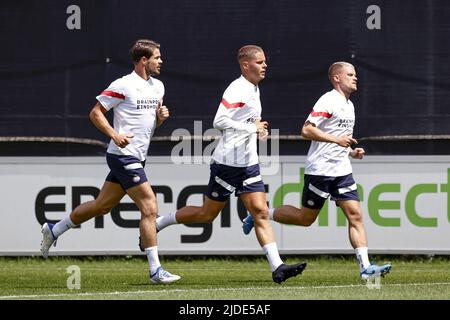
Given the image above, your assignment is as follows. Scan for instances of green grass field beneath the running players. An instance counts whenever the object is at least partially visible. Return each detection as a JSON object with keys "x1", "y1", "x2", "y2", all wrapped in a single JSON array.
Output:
[{"x1": 0, "y1": 256, "x2": 450, "y2": 300}]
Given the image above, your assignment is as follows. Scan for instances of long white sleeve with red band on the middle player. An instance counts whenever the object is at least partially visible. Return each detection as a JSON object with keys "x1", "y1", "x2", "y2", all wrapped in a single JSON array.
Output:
[{"x1": 213, "y1": 86, "x2": 256, "y2": 133}]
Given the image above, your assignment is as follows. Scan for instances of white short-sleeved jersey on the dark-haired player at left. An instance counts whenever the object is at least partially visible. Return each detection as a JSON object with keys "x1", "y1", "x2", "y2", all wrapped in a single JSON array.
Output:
[{"x1": 97, "y1": 71, "x2": 164, "y2": 161}]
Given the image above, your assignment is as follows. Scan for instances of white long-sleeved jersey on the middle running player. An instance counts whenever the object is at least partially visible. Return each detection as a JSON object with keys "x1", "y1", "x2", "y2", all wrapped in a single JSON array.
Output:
[{"x1": 212, "y1": 76, "x2": 261, "y2": 167}]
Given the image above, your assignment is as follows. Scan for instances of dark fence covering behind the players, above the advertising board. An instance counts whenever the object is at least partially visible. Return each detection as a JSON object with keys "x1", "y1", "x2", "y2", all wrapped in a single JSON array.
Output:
[{"x1": 0, "y1": 0, "x2": 450, "y2": 155}]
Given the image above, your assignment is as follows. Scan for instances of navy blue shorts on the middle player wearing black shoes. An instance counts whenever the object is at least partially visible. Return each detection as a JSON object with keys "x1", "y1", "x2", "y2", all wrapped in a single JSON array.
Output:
[{"x1": 206, "y1": 162, "x2": 266, "y2": 201}]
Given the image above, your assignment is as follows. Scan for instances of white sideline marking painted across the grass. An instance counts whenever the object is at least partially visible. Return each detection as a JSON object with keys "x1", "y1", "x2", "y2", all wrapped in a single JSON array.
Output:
[{"x1": 0, "y1": 282, "x2": 450, "y2": 300}]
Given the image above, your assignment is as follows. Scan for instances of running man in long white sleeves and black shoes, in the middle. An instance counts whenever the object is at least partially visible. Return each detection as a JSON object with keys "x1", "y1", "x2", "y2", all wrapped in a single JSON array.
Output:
[{"x1": 156, "y1": 45, "x2": 306, "y2": 283}]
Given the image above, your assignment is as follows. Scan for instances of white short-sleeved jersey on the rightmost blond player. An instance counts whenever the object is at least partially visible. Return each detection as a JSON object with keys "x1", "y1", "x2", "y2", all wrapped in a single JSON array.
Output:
[{"x1": 305, "y1": 89, "x2": 355, "y2": 177}]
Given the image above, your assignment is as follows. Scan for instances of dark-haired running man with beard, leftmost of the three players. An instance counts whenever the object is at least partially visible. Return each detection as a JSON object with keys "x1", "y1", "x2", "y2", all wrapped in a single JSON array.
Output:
[{"x1": 41, "y1": 39, "x2": 180, "y2": 284}]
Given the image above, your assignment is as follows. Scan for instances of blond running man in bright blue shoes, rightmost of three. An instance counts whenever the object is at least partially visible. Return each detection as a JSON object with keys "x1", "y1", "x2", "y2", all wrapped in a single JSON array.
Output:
[{"x1": 242, "y1": 62, "x2": 391, "y2": 280}]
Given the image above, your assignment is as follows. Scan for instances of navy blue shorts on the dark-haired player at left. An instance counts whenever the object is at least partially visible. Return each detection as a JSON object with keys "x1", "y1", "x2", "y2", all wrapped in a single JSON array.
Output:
[{"x1": 106, "y1": 153, "x2": 147, "y2": 190}]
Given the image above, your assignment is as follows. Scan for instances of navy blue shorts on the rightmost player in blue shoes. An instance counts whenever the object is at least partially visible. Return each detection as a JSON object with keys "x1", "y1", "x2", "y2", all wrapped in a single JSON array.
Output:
[{"x1": 302, "y1": 173, "x2": 359, "y2": 209}]
